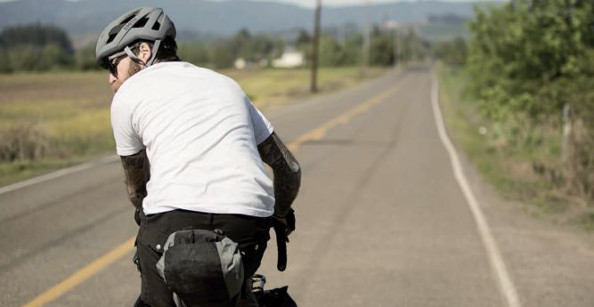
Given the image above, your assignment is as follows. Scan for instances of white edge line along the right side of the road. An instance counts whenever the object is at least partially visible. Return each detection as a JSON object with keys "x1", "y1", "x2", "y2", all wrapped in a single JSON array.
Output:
[{"x1": 431, "y1": 71, "x2": 521, "y2": 307}]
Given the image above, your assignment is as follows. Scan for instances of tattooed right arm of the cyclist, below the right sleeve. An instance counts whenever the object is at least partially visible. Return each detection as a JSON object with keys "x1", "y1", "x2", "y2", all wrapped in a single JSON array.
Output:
[{"x1": 258, "y1": 132, "x2": 301, "y2": 216}]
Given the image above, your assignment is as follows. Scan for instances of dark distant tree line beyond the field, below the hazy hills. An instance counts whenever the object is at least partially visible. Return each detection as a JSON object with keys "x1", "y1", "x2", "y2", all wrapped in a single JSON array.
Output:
[{"x1": 0, "y1": 23, "x2": 429, "y2": 73}]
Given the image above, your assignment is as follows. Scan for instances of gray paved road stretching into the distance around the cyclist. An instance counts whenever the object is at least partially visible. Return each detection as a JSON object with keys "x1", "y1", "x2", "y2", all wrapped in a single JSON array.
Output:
[{"x1": 0, "y1": 68, "x2": 594, "y2": 307}]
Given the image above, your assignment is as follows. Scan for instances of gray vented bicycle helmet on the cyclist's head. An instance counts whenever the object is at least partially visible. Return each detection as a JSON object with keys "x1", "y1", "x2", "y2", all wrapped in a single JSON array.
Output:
[{"x1": 95, "y1": 7, "x2": 176, "y2": 67}]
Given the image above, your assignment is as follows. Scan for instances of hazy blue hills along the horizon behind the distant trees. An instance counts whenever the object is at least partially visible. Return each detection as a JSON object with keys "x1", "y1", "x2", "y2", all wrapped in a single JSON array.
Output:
[{"x1": 0, "y1": 0, "x2": 501, "y2": 42}]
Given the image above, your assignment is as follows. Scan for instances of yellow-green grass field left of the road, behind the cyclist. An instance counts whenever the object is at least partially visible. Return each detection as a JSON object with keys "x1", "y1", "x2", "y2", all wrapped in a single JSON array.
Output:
[{"x1": 0, "y1": 68, "x2": 386, "y2": 185}]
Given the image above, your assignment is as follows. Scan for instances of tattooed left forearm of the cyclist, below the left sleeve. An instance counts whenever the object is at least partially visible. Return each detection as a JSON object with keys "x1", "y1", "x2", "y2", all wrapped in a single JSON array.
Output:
[{"x1": 121, "y1": 150, "x2": 150, "y2": 208}]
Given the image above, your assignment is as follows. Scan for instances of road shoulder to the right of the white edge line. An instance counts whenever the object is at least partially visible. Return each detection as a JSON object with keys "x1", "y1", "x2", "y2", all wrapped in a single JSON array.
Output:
[{"x1": 458, "y1": 132, "x2": 594, "y2": 307}]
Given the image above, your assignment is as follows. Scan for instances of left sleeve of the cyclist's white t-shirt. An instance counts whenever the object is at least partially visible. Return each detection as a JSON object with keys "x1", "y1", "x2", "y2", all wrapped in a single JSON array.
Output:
[{"x1": 111, "y1": 98, "x2": 144, "y2": 156}]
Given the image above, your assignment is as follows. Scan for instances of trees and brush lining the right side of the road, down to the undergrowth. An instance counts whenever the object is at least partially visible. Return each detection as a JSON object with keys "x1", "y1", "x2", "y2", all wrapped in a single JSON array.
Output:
[{"x1": 435, "y1": 0, "x2": 594, "y2": 203}]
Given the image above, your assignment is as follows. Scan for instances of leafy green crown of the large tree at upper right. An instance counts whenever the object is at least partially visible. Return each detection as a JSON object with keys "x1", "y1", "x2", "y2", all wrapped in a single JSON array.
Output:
[{"x1": 468, "y1": 0, "x2": 594, "y2": 119}]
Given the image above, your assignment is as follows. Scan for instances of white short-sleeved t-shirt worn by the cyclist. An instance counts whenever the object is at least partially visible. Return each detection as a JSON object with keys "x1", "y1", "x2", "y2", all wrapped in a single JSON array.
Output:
[{"x1": 111, "y1": 62, "x2": 274, "y2": 217}]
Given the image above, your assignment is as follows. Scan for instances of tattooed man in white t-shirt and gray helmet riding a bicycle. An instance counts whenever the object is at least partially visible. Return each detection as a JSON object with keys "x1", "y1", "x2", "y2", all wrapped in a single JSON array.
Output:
[{"x1": 96, "y1": 7, "x2": 301, "y2": 306}]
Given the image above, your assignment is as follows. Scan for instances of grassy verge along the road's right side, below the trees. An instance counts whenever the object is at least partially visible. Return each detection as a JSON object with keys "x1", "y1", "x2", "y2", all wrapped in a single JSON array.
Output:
[{"x1": 438, "y1": 66, "x2": 594, "y2": 231}]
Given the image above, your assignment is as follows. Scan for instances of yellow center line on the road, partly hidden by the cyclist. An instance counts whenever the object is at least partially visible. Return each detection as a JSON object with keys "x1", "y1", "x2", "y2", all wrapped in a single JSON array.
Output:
[{"x1": 24, "y1": 80, "x2": 398, "y2": 307}]
